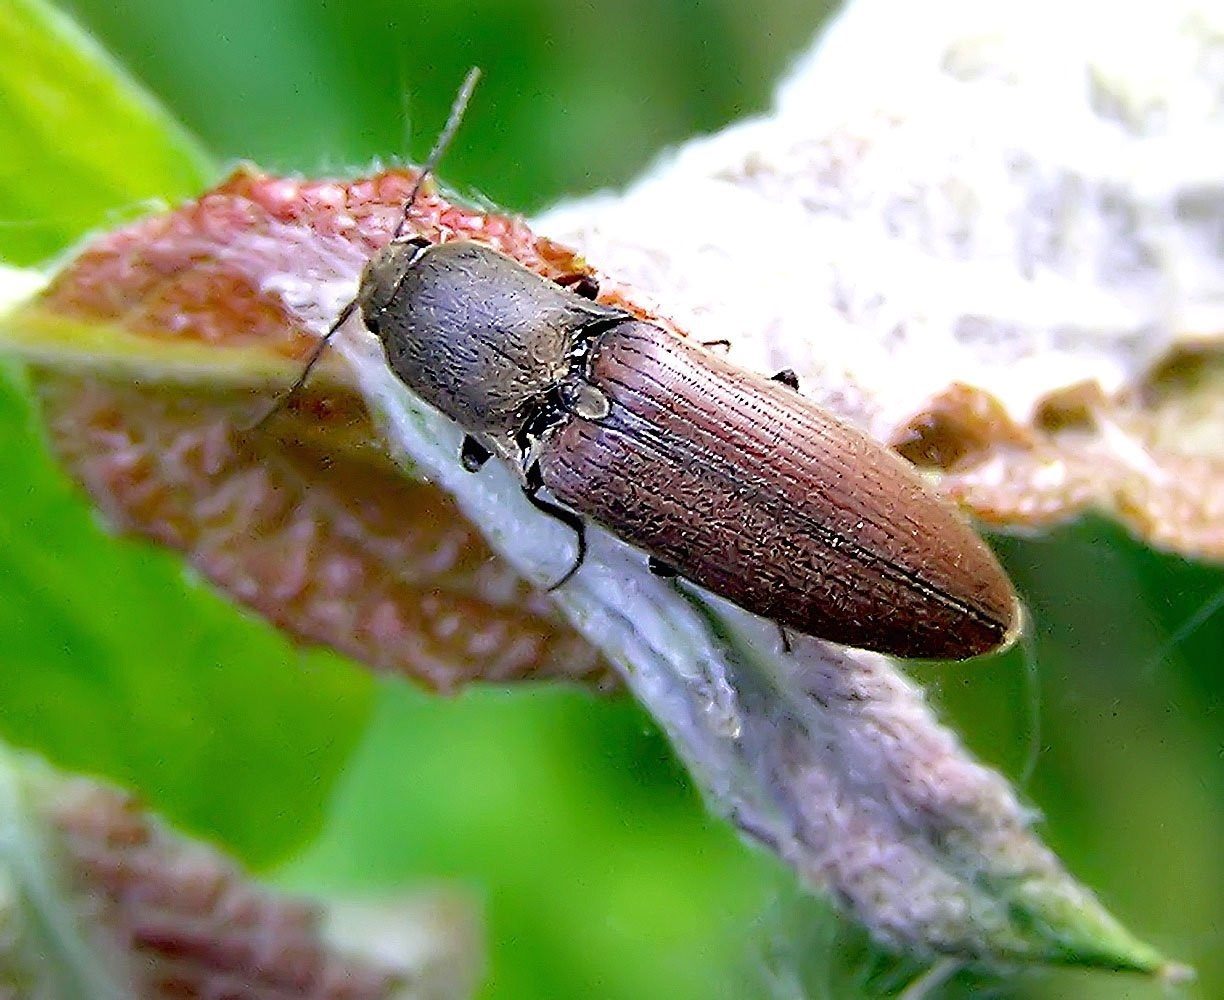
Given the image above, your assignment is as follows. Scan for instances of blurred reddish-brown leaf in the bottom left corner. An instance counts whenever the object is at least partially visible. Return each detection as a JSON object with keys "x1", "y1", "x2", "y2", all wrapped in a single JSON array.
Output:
[{"x1": 15, "y1": 769, "x2": 482, "y2": 1000}]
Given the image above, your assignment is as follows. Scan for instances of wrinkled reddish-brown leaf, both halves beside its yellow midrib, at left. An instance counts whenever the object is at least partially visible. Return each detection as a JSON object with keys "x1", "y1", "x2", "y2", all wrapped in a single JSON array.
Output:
[{"x1": 19, "y1": 170, "x2": 613, "y2": 690}]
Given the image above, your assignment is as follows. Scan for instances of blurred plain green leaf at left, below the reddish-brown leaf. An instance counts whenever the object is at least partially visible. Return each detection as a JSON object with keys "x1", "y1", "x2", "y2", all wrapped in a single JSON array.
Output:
[{"x1": 0, "y1": 352, "x2": 372, "y2": 862}]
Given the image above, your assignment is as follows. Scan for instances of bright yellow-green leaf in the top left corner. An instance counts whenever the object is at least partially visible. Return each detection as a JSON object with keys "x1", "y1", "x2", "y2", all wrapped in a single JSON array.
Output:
[{"x1": 0, "y1": 0, "x2": 217, "y2": 264}]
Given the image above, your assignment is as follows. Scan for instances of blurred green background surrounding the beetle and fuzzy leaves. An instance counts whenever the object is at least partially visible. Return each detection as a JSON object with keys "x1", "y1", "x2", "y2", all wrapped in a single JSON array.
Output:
[{"x1": 0, "y1": 0, "x2": 1224, "y2": 1000}]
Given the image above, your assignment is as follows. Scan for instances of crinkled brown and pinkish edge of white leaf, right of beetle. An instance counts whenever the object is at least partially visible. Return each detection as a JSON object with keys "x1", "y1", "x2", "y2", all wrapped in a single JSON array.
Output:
[{"x1": 895, "y1": 362, "x2": 1224, "y2": 561}]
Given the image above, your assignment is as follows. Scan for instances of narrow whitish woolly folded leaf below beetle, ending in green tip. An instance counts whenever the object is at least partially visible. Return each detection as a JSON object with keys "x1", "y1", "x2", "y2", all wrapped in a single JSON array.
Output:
[{"x1": 328, "y1": 281, "x2": 1164, "y2": 971}]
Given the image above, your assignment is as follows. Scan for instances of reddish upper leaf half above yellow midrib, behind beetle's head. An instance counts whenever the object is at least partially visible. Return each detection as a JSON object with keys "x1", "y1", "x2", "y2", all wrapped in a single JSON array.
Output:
[{"x1": 42, "y1": 168, "x2": 607, "y2": 360}]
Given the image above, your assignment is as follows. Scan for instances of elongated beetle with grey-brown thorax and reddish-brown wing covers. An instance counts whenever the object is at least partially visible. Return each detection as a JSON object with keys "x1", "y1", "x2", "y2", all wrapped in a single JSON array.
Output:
[{"x1": 357, "y1": 232, "x2": 1018, "y2": 659}]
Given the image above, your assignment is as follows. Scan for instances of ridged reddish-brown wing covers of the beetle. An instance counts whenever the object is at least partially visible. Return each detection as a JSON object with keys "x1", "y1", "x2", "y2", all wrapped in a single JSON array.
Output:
[{"x1": 540, "y1": 322, "x2": 1016, "y2": 659}]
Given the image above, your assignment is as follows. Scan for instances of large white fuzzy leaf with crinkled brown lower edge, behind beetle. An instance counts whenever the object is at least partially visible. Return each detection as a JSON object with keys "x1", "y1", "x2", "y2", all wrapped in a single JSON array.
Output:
[{"x1": 539, "y1": 0, "x2": 1224, "y2": 559}]
